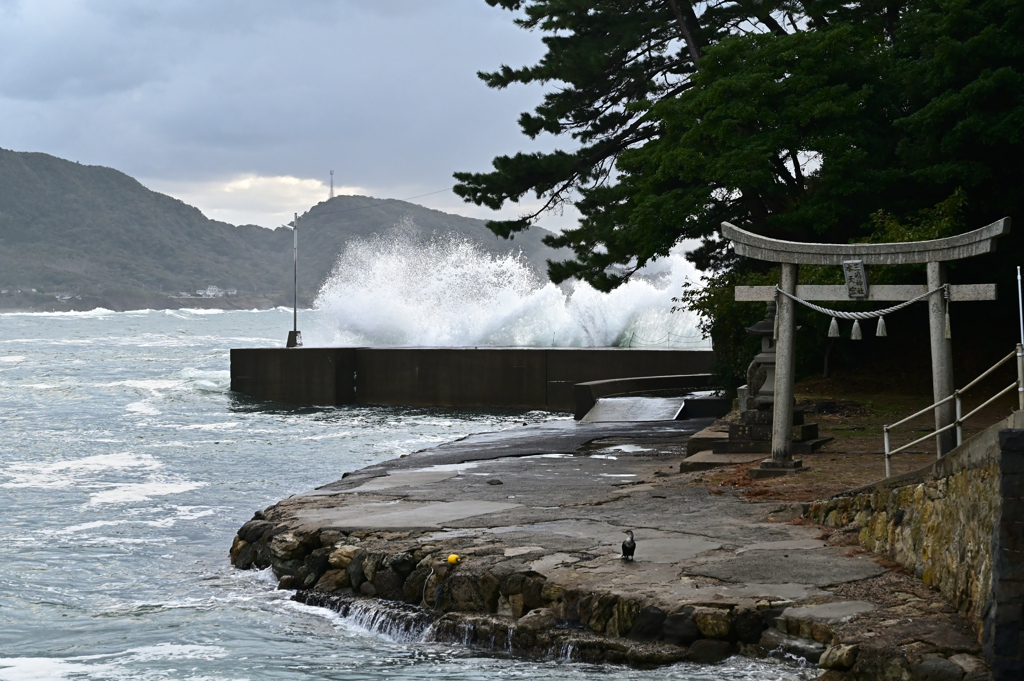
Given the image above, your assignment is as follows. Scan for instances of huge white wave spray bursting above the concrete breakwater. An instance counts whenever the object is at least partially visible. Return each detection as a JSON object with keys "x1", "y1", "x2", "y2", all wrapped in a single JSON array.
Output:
[{"x1": 305, "y1": 227, "x2": 711, "y2": 349}]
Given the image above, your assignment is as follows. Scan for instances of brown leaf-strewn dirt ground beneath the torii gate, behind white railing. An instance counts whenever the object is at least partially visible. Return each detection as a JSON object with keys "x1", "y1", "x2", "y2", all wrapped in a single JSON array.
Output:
[{"x1": 694, "y1": 377, "x2": 1017, "y2": 502}]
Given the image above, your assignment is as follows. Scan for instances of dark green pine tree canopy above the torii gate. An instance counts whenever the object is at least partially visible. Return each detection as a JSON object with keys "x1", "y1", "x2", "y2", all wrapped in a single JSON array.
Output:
[{"x1": 456, "y1": 0, "x2": 1024, "y2": 290}]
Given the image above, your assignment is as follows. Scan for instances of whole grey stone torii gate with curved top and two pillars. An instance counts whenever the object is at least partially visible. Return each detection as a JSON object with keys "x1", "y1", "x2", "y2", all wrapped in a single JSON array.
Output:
[{"x1": 722, "y1": 217, "x2": 1010, "y2": 475}]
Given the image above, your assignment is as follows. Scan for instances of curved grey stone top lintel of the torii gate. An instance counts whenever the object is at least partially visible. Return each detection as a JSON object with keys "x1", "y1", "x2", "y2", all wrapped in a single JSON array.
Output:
[{"x1": 722, "y1": 217, "x2": 1010, "y2": 265}]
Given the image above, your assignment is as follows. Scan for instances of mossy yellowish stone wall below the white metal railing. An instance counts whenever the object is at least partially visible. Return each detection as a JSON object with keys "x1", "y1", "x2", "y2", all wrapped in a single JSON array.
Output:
[{"x1": 804, "y1": 412, "x2": 1024, "y2": 679}]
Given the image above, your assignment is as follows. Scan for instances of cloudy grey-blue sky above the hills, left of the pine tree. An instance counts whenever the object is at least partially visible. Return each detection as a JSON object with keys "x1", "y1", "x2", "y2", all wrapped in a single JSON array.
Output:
[{"x1": 0, "y1": 0, "x2": 585, "y2": 228}]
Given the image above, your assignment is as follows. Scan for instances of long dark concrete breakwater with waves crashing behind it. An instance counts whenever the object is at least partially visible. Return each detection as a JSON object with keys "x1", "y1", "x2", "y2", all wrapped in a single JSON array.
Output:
[{"x1": 231, "y1": 347, "x2": 715, "y2": 412}]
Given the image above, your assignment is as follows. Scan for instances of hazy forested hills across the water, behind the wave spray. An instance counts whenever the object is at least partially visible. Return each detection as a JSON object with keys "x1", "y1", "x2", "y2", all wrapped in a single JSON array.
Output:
[{"x1": 0, "y1": 150, "x2": 557, "y2": 309}]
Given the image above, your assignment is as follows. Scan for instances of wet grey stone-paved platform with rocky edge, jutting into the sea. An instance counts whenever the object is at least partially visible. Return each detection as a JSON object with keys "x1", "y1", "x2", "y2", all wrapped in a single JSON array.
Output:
[{"x1": 231, "y1": 419, "x2": 991, "y2": 680}]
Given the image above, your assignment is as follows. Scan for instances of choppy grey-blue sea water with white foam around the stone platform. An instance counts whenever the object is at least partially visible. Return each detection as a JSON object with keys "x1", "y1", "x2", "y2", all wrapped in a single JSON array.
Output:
[{"x1": 0, "y1": 310, "x2": 814, "y2": 681}]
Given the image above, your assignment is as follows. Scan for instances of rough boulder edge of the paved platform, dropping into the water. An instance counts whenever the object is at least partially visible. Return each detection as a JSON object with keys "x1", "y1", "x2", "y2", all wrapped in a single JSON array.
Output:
[{"x1": 230, "y1": 522, "x2": 790, "y2": 667}]
